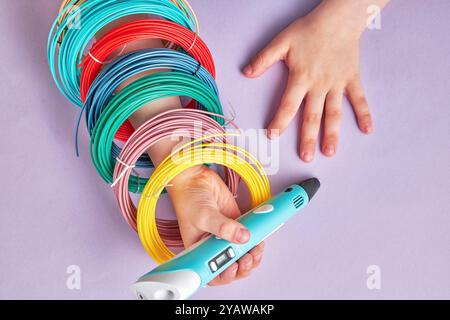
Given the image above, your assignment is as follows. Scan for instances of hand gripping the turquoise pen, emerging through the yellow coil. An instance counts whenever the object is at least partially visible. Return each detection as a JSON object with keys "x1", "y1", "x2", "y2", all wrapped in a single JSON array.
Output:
[{"x1": 168, "y1": 166, "x2": 264, "y2": 285}]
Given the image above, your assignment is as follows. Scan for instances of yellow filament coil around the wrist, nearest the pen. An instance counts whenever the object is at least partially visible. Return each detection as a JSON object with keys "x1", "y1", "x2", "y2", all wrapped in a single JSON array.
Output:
[{"x1": 137, "y1": 134, "x2": 270, "y2": 264}]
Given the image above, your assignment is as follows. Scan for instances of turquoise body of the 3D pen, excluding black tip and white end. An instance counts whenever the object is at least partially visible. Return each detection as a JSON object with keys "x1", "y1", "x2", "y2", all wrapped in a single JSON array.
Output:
[{"x1": 139, "y1": 184, "x2": 309, "y2": 291}]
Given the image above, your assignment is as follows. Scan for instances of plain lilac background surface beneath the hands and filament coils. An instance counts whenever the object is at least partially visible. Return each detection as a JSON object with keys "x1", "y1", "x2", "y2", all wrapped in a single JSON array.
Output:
[{"x1": 0, "y1": 0, "x2": 450, "y2": 299}]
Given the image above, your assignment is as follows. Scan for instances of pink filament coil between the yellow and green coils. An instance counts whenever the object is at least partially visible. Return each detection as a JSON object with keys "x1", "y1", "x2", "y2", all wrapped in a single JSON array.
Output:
[{"x1": 113, "y1": 109, "x2": 240, "y2": 248}]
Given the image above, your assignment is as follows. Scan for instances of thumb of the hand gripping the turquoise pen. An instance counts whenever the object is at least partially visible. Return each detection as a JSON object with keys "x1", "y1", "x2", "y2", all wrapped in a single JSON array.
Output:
[{"x1": 197, "y1": 211, "x2": 250, "y2": 243}]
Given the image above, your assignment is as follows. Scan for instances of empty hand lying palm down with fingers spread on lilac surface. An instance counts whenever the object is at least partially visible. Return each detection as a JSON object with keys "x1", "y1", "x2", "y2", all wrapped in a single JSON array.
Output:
[{"x1": 244, "y1": 6, "x2": 373, "y2": 162}]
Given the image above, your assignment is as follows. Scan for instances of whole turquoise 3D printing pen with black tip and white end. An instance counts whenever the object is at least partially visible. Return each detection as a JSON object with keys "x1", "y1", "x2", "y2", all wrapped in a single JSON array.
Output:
[{"x1": 131, "y1": 178, "x2": 320, "y2": 300}]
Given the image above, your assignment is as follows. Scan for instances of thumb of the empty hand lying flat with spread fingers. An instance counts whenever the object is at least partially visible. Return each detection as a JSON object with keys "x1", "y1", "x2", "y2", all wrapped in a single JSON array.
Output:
[{"x1": 242, "y1": 39, "x2": 286, "y2": 78}]
